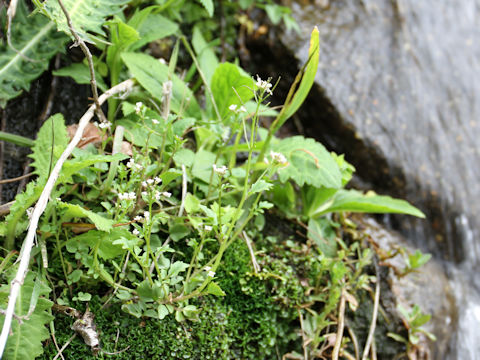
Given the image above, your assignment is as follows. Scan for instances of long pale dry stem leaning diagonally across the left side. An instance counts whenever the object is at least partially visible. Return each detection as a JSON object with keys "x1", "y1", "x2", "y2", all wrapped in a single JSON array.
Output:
[{"x1": 0, "y1": 79, "x2": 134, "y2": 358}]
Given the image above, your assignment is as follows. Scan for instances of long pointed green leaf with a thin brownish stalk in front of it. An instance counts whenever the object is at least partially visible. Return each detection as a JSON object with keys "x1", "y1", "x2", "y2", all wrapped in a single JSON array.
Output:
[{"x1": 122, "y1": 53, "x2": 201, "y2": 117}]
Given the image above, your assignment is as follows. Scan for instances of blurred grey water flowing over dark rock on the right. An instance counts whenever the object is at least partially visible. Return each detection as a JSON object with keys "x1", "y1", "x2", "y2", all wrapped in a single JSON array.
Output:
[{"x1": 282, "y1": 0, "x2": 480, "y2": 360}]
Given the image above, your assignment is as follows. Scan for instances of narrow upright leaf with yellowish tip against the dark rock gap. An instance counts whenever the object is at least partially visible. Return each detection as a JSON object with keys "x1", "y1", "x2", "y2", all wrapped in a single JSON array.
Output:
[{"x1": 276, "y1": 27, "x2": 320, "y2": 129}]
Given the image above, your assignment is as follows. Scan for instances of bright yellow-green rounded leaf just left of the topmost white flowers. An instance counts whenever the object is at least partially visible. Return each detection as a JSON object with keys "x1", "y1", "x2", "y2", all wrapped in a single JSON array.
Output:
[{"x1": 211, "y1": 62, "x2": 253, "y2": 118}]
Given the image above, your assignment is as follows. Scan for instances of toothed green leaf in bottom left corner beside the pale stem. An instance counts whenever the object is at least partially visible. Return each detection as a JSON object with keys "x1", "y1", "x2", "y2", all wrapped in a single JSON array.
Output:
[{"x1": 0, "y1": 272, "x2": 53, "y2": 360}]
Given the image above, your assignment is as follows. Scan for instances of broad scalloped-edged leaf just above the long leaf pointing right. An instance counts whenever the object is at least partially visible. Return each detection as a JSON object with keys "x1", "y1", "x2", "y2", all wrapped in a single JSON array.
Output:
[{"x1": 273, "y1": 136, "x2": 342, "y2": 189}]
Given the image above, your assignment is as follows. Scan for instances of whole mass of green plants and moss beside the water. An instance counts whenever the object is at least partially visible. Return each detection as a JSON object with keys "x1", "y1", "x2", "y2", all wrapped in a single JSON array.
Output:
[{"x1": 0, "y1": 0, "x2": 434, "y2": 359}]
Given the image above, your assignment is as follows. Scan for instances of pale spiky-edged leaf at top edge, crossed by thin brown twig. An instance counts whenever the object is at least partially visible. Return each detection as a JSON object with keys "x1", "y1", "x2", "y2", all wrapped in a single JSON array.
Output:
[{"x1": 37, "y1": 0, "x2": 129, "y2": 42}]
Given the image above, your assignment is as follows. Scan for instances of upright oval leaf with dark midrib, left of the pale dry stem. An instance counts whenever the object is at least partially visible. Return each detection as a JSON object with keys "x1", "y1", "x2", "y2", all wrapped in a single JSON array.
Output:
[{"x1": 29, "y1": 114, "x2": 69, "y2": 183}]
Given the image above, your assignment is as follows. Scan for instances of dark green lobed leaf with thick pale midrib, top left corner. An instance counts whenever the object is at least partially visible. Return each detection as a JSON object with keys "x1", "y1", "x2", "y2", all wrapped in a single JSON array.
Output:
[{"x1": 0, "y1": 0, "x2": 68, "y2": 108}]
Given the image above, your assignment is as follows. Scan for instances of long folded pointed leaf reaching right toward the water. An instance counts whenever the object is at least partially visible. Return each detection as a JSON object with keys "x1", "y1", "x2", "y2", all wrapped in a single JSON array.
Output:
[{"x1": 314, "y1": 190, "x2": 425, "y2": 218}]
